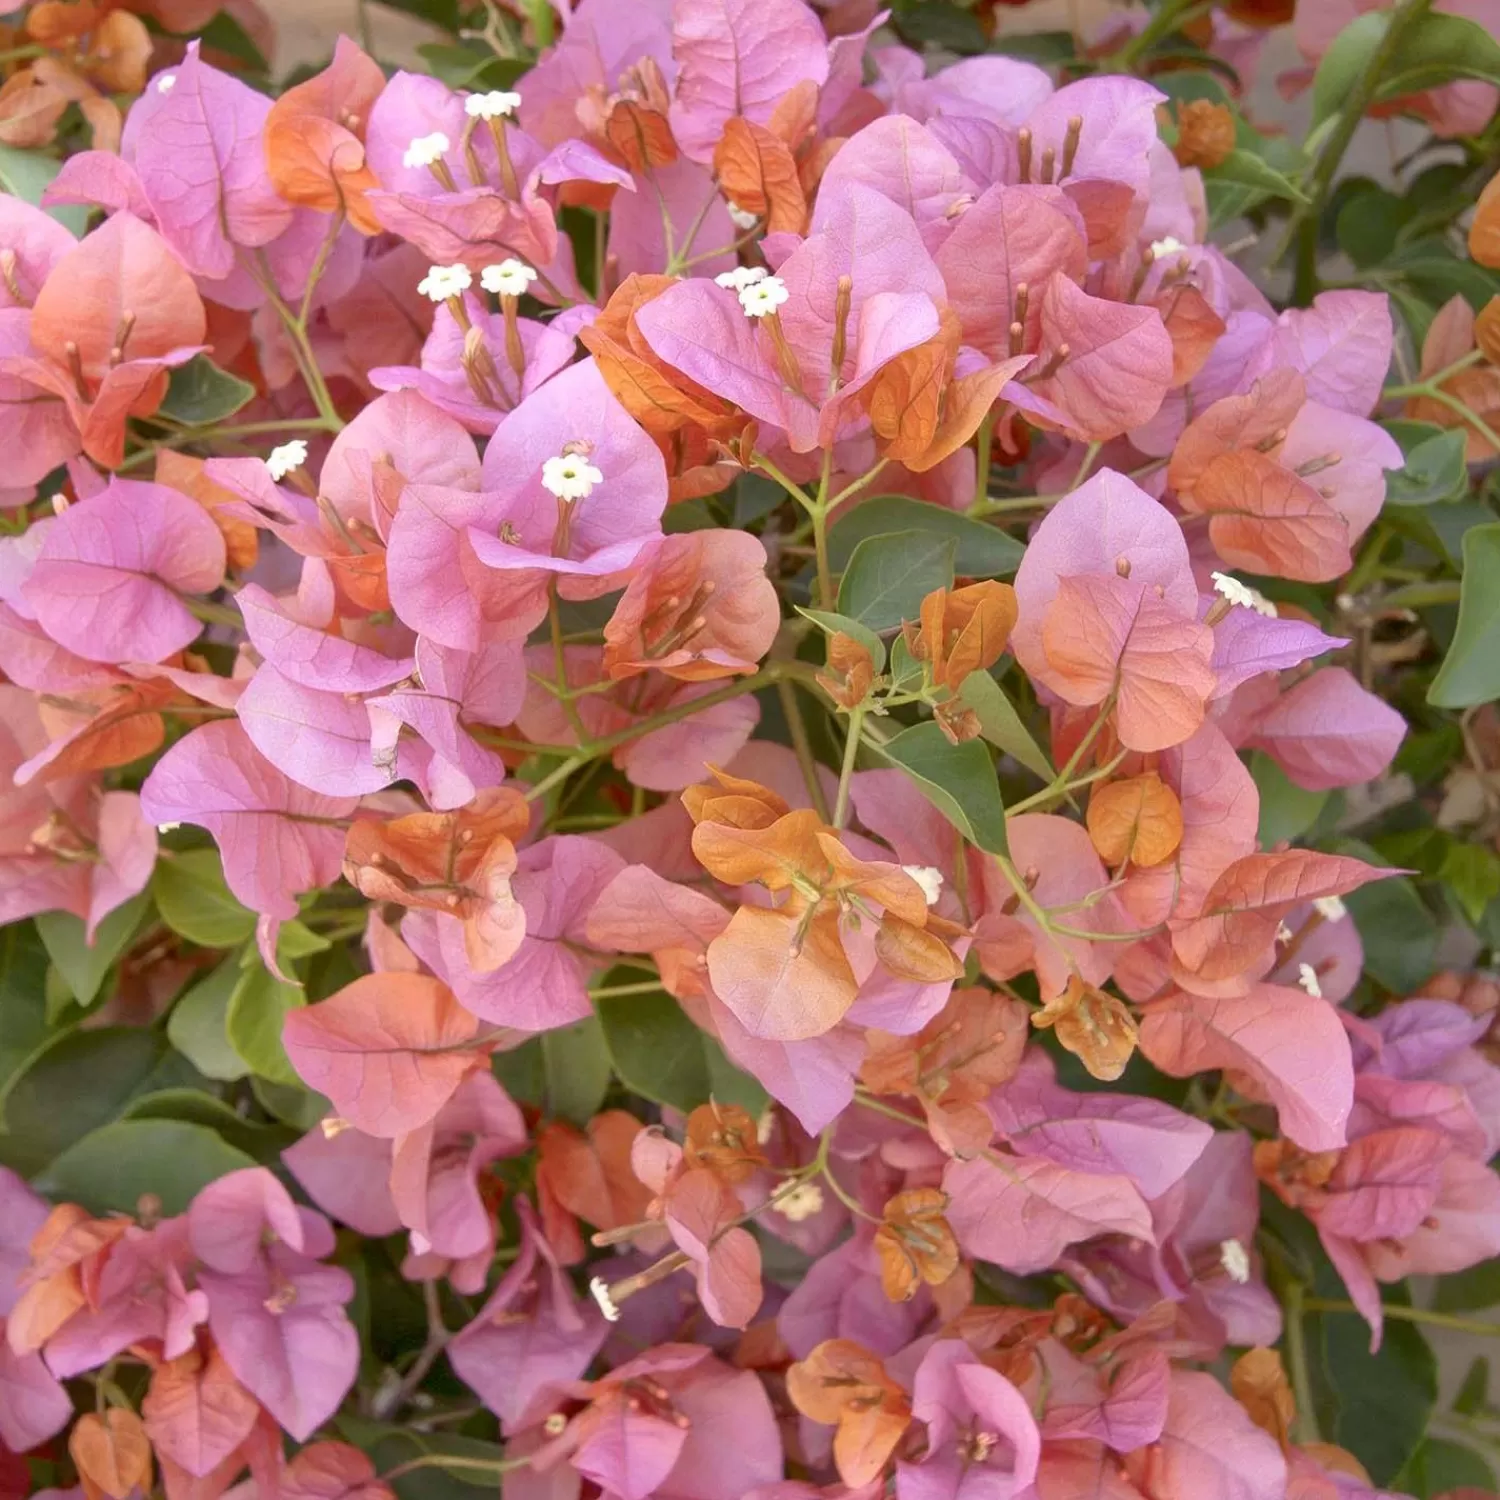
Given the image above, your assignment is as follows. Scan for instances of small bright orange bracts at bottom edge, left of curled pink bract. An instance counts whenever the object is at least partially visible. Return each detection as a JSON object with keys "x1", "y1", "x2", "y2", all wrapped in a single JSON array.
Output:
[{"x1": 786, "y1": 1338, "x2": 912, "y2": 1490}]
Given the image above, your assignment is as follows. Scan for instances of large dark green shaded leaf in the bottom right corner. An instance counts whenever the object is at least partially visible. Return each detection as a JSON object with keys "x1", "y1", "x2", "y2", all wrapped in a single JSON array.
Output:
[{"x1": 1307, "y1": 1269, "x2": 1437, "y2": 1488}]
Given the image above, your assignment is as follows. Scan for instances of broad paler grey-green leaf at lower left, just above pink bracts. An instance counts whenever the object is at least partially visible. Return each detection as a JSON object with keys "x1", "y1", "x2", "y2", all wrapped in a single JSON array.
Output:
[{"x1": 38, "y1": 1121, "x2": 255, "y2": 1214}]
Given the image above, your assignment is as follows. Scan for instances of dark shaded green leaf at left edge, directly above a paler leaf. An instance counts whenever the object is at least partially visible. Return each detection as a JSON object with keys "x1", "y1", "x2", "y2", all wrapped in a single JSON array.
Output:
[{"x1": 0, "y1": 1026, "x2": 191, "y2": 1178}]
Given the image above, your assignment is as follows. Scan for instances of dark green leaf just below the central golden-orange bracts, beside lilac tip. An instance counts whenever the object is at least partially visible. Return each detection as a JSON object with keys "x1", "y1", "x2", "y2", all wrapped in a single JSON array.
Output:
[{"x1": 594, "y1": 990, "x2": 764, "y2": 1110}]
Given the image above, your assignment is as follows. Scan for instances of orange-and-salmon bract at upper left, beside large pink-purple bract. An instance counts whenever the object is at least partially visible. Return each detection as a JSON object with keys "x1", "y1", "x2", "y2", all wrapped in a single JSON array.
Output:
[{"x1": 266, "y1": 36, "x2": 386, "y2": 234}]
